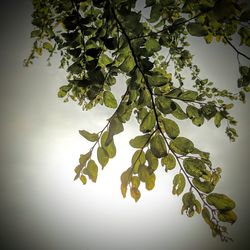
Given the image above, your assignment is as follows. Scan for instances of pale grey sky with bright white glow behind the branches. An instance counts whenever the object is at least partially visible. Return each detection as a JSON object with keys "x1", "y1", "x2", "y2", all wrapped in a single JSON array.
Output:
[{"x1": 0, "y1": 0, "x2": 250, "y2": 250}]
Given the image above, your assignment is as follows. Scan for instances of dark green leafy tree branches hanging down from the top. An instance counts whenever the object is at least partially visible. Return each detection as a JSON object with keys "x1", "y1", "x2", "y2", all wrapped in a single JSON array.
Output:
[{"x1": 25, "y1": 0, "x2": 250, "y2": 241}]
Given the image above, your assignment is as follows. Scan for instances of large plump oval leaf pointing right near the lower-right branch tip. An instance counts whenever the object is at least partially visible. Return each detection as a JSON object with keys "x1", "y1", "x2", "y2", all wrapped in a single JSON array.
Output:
[{"x1": 206, "y1": 193, "x2": 235, "y2": 211}]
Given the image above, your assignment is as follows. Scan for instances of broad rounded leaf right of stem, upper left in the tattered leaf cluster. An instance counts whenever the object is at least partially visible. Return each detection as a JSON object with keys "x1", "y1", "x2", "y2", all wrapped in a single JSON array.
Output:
[{"x1": 183, "y1": 158, "x2": 206, "y2": 178}]
